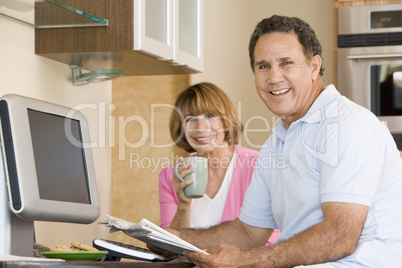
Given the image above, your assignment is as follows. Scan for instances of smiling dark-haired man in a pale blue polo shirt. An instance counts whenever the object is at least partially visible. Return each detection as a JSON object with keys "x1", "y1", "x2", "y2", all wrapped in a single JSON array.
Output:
[{"x1": 171, "y1": 15, "x2": 402, "y2": 268}]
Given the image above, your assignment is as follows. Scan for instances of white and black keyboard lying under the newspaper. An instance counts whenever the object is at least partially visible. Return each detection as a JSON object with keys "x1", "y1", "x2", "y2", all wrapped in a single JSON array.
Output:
[{"x1": 92, "y1": 239, "x2": 167, "y2": 261}]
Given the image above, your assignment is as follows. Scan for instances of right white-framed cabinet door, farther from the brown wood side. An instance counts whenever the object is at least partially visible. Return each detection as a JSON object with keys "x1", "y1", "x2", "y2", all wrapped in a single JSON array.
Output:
[{"x1": 173, "y1": 0, "x2": 203, "y2": 72}]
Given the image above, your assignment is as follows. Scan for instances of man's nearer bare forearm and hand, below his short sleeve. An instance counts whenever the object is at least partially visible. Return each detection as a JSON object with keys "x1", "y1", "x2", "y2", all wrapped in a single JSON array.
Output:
[{"x1": 186, "y1": 203, "x2": 368, "y2": 267}]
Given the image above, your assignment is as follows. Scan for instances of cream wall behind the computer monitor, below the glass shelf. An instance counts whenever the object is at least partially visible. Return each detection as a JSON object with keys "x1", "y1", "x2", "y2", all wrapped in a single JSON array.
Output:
[{"x1": 0, "y1": 17, "x2": 112, "y2": 246}]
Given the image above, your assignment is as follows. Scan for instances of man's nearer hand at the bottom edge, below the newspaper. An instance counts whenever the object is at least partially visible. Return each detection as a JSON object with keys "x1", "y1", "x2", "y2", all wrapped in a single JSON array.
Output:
[{"x1": 184, "y1": 244, "x2": 252, "y2": 268}]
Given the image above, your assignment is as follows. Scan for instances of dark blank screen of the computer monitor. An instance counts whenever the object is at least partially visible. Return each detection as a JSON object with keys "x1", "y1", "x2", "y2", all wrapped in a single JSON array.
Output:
[{"x1": 28, "y1": 109, "x2": 90, "y2": 204}]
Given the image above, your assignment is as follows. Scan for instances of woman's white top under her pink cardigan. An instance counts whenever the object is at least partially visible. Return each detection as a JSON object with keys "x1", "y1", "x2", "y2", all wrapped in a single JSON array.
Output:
[{"x1": 190, "y1": 152, "x2": 236, "y2": 228}]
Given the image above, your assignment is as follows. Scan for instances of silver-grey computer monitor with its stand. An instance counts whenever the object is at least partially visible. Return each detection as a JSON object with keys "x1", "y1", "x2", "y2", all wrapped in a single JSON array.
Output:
[{"x1": 0, "y1": 94, "x2": 99, "y2": 256}]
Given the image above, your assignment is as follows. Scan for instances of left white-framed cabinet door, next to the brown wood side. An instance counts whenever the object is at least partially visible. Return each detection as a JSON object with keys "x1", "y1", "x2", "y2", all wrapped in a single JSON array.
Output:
[{"x1": 134, "y1": 0, "x2": 174, "y2": 61}]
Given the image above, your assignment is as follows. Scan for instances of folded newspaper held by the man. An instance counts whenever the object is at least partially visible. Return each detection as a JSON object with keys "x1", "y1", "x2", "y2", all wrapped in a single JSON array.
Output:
[{"x1": 99, "y1": 214, "x2": 209, "y2": 255}]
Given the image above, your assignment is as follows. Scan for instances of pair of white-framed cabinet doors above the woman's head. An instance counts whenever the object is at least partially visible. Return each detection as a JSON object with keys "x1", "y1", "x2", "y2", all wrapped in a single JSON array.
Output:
[{"x1": 134, "y1": 0, "x2": 203, "y2": 72}]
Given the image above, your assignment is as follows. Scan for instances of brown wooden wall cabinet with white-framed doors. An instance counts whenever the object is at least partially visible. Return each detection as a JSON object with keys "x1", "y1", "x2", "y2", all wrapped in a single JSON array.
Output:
[{"x1": 35, "y1": 0, "x2": 202, "y2": 76}]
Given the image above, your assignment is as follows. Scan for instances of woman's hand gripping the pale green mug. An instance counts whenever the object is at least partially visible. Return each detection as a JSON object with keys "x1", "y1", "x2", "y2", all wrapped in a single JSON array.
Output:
[{"x1": 172, "y1": 157, "x2": 194, "y2": 206}]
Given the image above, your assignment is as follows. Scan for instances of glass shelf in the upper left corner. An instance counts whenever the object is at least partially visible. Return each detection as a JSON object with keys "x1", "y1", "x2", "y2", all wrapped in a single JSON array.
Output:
[{"x1": 0, "y1": 0, "x2": 108, "y2": 28}]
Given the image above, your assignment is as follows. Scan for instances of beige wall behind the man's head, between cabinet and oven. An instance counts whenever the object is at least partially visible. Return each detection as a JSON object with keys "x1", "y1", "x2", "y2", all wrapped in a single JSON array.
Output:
[{"x1": 191, "y1": 0, "x2": 333, "y2": 150}]
